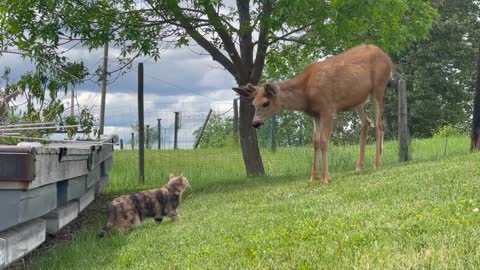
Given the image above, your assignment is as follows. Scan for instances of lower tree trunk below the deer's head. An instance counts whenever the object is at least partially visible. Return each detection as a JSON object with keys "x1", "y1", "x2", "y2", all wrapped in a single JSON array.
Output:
[{"x1": 240, "y1": 98, "x2": 265, "y2": 176}]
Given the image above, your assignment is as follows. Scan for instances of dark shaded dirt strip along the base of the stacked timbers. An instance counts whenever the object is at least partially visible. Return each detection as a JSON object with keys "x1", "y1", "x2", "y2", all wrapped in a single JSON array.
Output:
[{"x1": 5, "y1": 194, "x2": 112, "y2": 270}]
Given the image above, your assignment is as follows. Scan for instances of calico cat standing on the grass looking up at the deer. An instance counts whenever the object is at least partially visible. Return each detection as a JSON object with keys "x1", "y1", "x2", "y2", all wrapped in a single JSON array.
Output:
[{"x1": 98, "y1": 173, "x2": 190, "y2": 237}]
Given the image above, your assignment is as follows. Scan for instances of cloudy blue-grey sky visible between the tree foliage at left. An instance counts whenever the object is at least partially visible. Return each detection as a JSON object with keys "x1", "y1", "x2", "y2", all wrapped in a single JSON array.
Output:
[{"x1": 0, "y1": 42, "x2": 236, "y2": 148}]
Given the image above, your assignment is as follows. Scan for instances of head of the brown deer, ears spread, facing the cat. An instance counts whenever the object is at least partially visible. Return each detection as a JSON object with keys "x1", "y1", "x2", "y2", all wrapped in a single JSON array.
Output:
[{"x1": 232, "y1": 83, "x2": 282, "y2": 128}]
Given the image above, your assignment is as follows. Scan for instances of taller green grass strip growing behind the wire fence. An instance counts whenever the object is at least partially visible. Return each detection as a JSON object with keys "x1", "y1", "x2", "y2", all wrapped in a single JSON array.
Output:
[{"x1": 108, "y1": 136, "x2": 469, "y2": 194}]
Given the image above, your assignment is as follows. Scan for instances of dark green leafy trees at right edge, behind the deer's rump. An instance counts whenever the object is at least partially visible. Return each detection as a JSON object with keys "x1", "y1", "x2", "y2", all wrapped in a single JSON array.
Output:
[{"x1": 386, "y1": 0, "x2": 480, "y2": 138}]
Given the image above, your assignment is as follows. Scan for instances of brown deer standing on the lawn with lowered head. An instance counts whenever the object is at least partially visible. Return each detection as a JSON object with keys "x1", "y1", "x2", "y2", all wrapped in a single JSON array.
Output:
[{"x1": 233, "y1": 45, "x2": 393, "y2": 184}]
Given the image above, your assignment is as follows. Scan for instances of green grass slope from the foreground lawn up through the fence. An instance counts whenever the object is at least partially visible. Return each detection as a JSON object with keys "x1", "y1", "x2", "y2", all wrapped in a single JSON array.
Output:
[{"x1": 34, "y1": 138, "x2": 480, "y2": 269}]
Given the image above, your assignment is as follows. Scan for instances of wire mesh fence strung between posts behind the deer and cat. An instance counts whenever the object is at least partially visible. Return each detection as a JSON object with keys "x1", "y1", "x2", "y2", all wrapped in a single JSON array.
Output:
[{"x1": 107, "y1": 97, "x2": 469, "y2": 188}]
